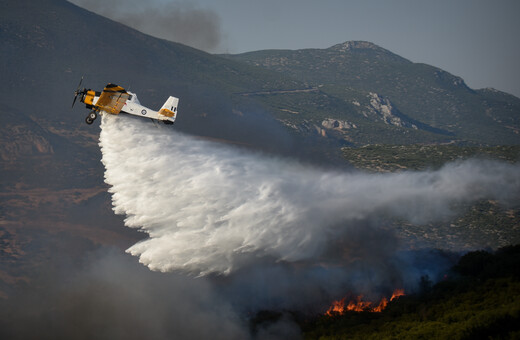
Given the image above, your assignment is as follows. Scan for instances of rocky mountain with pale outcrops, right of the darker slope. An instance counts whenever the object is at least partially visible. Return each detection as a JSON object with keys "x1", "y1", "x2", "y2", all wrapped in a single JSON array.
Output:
[{"x1": 225, "y1": 41, "x2": 520, "y2": 144}]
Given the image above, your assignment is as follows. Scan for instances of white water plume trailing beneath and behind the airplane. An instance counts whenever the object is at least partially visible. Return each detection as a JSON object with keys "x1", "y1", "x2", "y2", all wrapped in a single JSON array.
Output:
[{"x1": 100, "y1": 115, "x2": 520, "y2": 282}]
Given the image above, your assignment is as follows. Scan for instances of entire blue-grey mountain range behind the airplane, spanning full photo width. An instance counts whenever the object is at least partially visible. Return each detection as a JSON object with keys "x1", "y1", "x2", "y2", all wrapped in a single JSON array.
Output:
[{"x1": 0, "y1": 0, "x2": 520, "y2": 175}]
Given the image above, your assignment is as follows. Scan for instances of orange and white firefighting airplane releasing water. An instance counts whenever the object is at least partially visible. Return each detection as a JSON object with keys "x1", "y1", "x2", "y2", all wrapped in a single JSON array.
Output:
[{"x1": 72, "y1": 77, "x2": 179, "y2": 124}]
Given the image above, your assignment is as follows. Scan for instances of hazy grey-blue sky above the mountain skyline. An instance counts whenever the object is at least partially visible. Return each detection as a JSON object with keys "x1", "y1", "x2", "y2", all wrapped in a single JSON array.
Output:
[{"x1": 71, "y1": 0, "x2": 520, "y2": 97}]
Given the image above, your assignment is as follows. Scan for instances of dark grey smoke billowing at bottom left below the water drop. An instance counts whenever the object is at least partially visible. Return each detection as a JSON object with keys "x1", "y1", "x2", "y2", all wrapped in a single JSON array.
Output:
[{"x1": 0, "y1": 248, "x2": 249, "y2": 339}]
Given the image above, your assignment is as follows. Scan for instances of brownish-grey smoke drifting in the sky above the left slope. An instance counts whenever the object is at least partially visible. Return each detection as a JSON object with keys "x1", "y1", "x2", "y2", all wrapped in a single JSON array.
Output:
[{"x1": 67, "y1": 0, "x2": 222, "y2": 52}]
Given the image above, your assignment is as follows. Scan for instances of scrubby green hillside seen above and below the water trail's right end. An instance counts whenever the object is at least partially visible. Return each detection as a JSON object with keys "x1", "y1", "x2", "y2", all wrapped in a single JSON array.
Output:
[{"x1": 342, "y1": 144, "x2": 520, "y2": 250}]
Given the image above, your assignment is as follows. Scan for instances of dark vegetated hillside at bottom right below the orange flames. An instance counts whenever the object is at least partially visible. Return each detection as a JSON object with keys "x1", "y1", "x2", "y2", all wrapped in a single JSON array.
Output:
[{"x1": 302, "y1": 245, "x2": 520, "y2": 340}]
